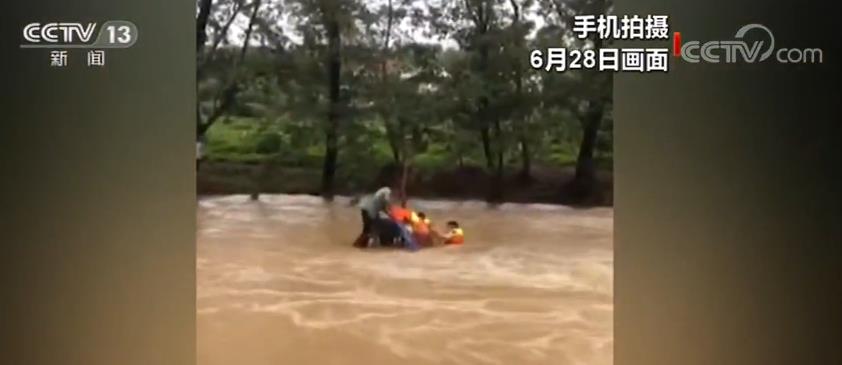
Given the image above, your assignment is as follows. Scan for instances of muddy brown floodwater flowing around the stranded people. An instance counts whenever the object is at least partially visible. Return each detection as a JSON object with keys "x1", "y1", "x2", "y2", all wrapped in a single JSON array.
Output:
[{"x1": 197, "y1": 195, "x2": 613, "y2": 365}]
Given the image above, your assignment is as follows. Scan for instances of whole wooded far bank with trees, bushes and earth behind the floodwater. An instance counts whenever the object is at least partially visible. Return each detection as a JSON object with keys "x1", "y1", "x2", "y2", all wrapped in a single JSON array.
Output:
[{"x1": 196, "y1": 0, "x2": 613, "y2": 204}]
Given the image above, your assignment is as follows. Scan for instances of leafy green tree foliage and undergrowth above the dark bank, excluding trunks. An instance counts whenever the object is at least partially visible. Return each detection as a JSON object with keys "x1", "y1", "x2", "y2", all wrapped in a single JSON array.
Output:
[{"x1": 197, "y1": 0, "x2": 613, "y2": 184}]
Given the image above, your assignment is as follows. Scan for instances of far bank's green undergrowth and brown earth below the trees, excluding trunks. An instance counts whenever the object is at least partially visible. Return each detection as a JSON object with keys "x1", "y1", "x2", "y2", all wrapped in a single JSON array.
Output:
[{"x1": 197, "y1": 118, "x2": 613, "y2": 205}]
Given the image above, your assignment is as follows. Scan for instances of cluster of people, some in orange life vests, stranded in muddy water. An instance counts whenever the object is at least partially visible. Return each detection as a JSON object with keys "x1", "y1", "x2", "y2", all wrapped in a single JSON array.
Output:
[{"x1": 354, "y1": 187, "x2": 465, "y2": 250}]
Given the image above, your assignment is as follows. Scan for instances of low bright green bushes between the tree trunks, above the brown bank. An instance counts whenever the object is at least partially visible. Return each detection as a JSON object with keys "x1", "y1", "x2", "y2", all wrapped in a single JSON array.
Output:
[{"x1": 206, "y1": 116, "x2": 612, "y2": 176}]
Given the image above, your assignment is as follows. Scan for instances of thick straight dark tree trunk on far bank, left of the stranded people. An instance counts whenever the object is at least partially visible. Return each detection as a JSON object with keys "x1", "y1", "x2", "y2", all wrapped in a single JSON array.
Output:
[{"x1": 322, "y1": 14, "x2": 342, "y2": 199}]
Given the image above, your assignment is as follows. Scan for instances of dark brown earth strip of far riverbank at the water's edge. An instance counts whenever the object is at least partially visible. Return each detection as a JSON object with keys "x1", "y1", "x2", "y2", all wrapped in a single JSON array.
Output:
[{"x1": 197, "y1": 161, "x2": 613, "y2": 206}]
